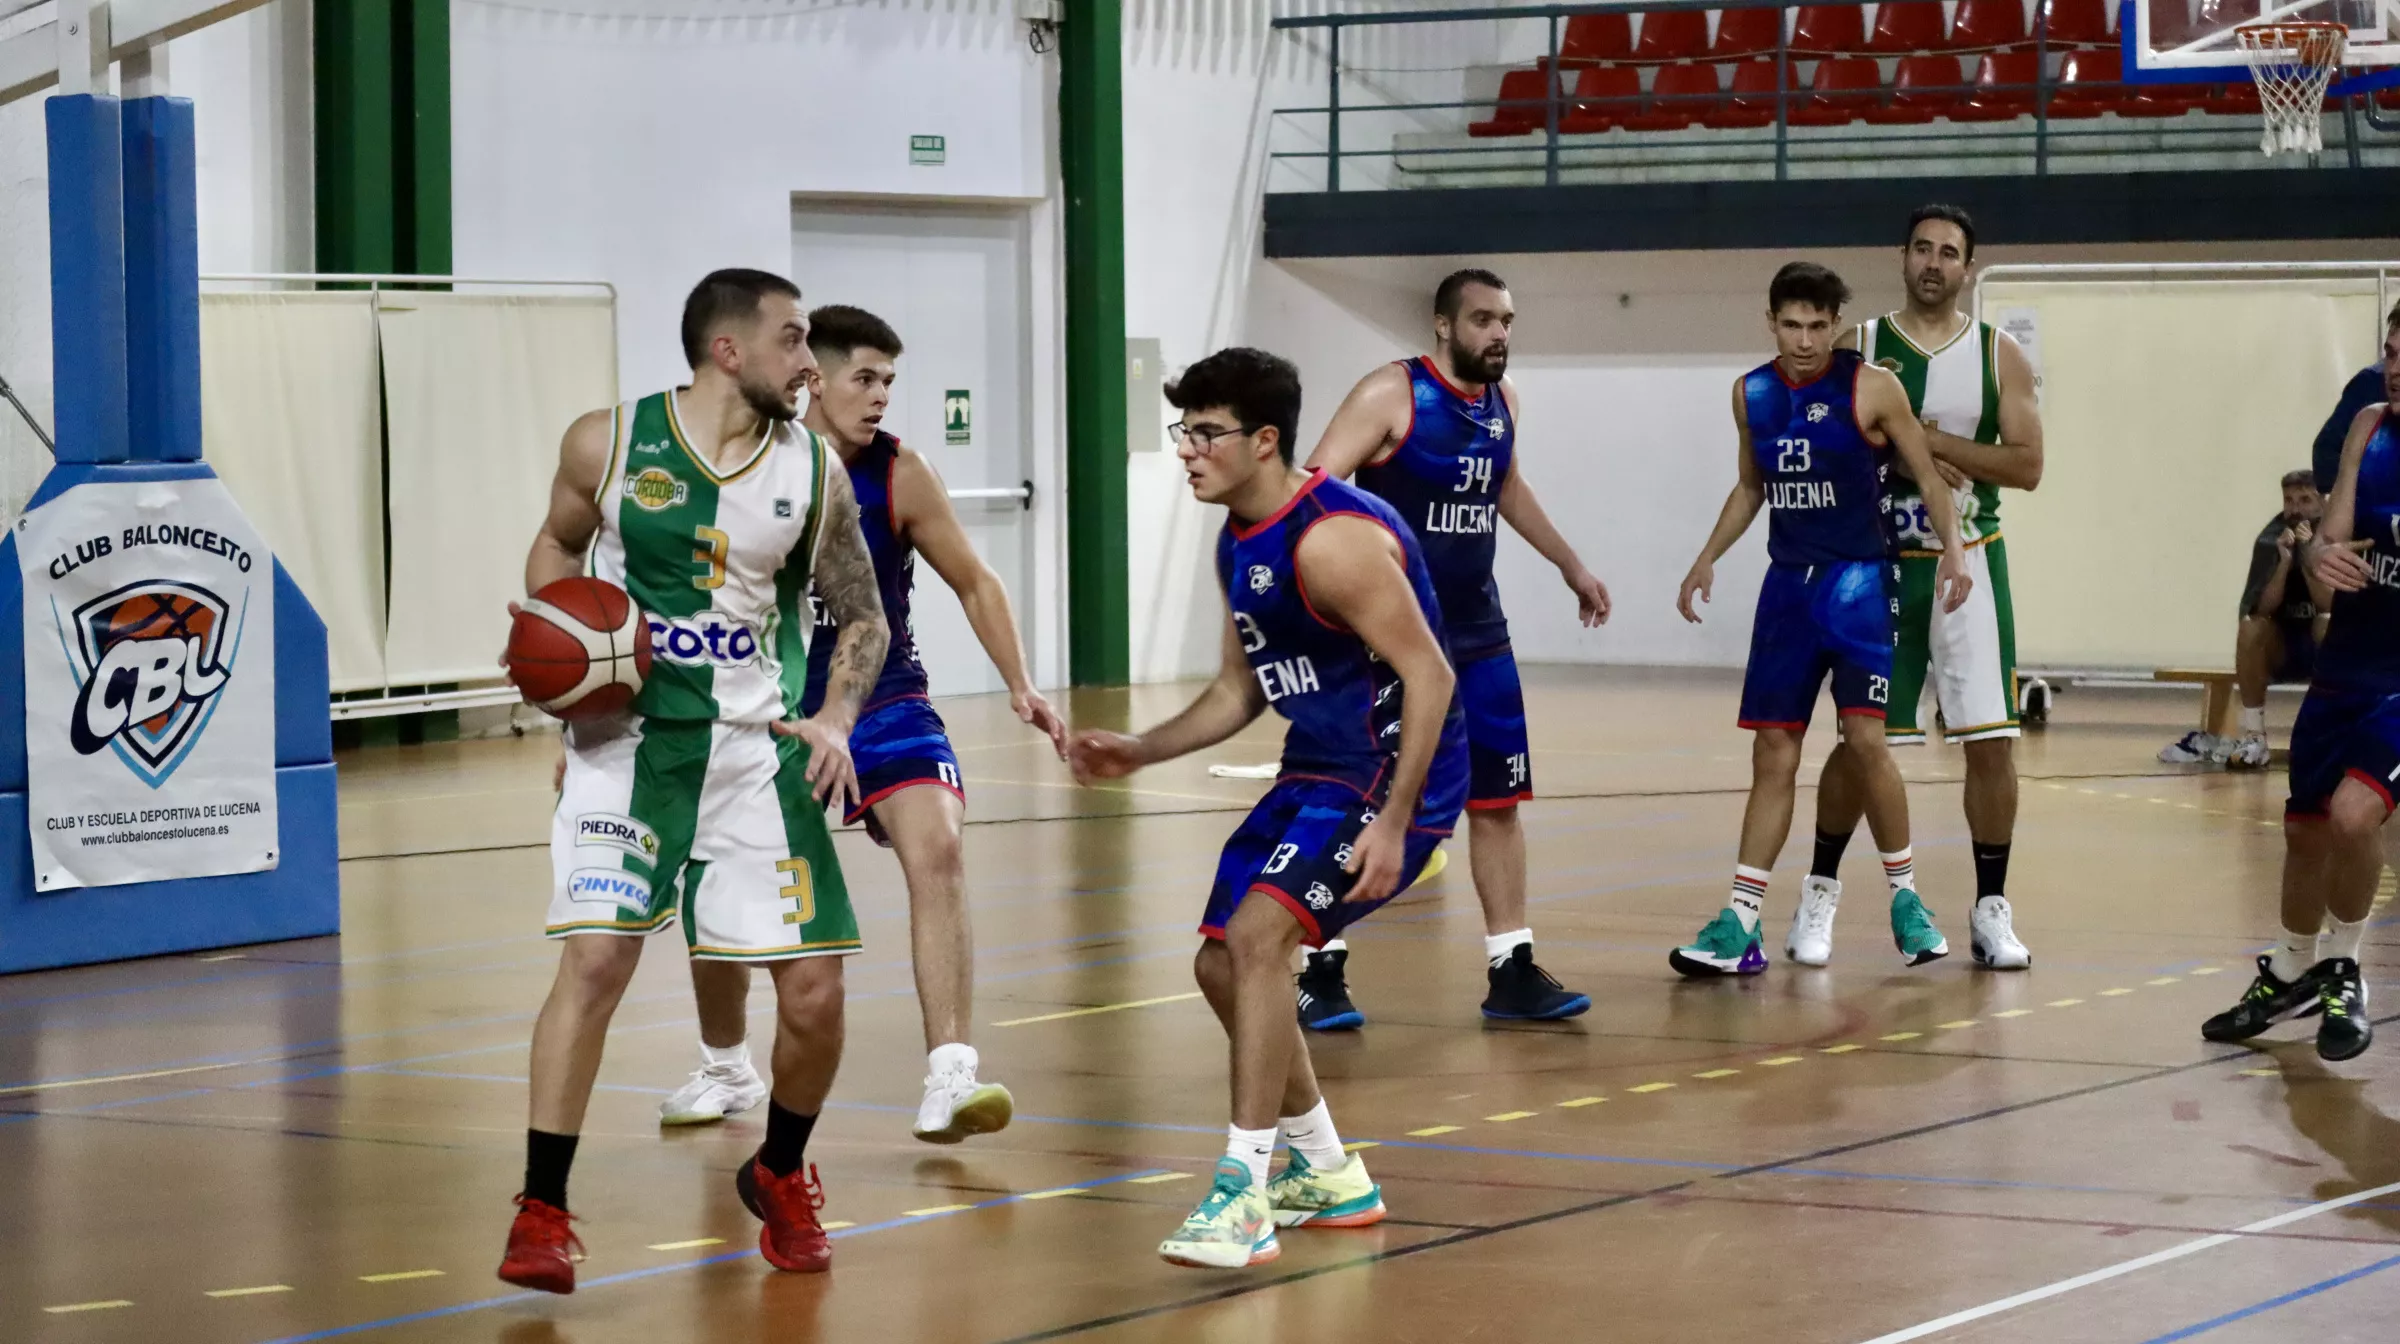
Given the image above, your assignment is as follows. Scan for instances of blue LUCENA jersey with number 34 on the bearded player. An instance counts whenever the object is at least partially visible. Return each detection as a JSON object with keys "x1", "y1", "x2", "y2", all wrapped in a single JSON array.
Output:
[{"x1": 1358, "y1": 358, "x2": 1517, "y2": 662}]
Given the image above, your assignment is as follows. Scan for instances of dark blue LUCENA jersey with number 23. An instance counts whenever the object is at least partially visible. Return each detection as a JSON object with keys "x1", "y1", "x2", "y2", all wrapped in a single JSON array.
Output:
[{"x1": 1742, "y1": 350, "x2": 1891, "y2": 564}]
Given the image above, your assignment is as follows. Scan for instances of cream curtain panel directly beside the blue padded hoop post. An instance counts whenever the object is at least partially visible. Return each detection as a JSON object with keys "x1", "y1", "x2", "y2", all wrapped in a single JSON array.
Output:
[{"x1": 199, "y1": 293, "x2": 384, "y2": 691}]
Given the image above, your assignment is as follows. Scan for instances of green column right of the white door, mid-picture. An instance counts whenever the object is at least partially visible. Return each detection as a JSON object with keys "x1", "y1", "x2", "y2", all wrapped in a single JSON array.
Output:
[{"x1": 1058, "y1": 0, "x2": 1133, "y2": 686}]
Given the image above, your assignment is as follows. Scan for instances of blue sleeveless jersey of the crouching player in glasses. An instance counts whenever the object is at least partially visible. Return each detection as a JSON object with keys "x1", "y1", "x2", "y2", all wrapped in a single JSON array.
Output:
[{"x1": 1217, "y1": 470, "x2": 1466, "y2": 828}]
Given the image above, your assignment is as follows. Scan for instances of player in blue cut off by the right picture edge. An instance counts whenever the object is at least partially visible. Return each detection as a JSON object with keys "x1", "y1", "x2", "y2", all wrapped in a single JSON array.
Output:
[{"x1": 2201, "y1": 329, "x2": 2400, "y2": 1061}]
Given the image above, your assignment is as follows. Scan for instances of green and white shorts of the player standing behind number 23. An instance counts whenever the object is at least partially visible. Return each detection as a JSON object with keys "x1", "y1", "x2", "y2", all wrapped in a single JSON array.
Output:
[{"x1": 1884, "y1": 535, "x2": 2023, "y2": 746}]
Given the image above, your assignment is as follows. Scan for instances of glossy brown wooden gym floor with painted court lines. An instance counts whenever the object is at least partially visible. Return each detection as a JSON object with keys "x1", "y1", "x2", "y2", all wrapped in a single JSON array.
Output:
[{"x1": 0, "y1": 670, "x2": 2400, "y2": 1344}]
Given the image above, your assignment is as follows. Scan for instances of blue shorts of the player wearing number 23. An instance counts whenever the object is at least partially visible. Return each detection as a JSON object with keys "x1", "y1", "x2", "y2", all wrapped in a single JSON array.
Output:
[{"x1": 1740, "y1": 559, "x2": 1898, "y2": 732}]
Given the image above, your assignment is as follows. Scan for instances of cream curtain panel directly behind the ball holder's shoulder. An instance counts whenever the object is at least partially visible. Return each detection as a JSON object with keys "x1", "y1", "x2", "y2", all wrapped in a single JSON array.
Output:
[{"x1": 382, "y1": 293, "x2": 617, "y2": 686}]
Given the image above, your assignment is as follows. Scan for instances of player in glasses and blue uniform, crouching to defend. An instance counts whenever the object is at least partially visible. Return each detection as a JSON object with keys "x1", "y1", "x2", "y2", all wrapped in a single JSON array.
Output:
[{"x1": 1070, "y1": 350, "x2": 1466, "y2": 1270}]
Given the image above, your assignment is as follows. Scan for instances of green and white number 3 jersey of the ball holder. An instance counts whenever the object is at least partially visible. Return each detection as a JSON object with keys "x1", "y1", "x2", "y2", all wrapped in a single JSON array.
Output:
[{"x1": 590, "y1": 391, "x2": 835, "y2": 725}]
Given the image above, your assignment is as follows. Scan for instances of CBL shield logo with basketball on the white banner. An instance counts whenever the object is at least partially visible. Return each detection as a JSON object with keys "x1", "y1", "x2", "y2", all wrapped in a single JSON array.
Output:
[{"x1": 50, "y1": 578, "x2": 247, "y2": 790}]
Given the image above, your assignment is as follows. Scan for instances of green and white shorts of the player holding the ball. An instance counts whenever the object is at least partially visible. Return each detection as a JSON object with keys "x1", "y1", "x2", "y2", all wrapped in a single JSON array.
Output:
[{"x1": 547, "y1": 720, "x2": 859, "y2": 962}]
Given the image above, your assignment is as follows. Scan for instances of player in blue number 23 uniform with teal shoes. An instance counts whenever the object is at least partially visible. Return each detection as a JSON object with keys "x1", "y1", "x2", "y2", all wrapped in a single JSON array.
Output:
[{"x1": 1668, "y1": 262, "x2": 1973, "y2": 977}]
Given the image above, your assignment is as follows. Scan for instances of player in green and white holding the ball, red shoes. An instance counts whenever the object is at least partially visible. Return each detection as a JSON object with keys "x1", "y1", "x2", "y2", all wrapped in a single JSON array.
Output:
[{"x1": 499, "y1": 271, "x2": 888, "y2": 1294}]
